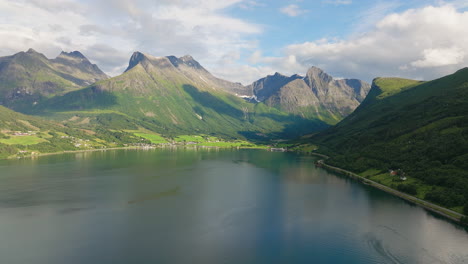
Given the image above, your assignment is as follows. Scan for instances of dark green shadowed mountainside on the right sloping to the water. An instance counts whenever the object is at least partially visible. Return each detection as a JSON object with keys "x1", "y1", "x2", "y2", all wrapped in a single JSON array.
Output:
[{"x1": 306, "y1": 68, "x2": 468, "y2": 211}]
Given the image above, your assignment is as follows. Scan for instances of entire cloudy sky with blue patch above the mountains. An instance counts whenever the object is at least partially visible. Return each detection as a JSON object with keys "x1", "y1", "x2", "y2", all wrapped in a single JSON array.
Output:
[{"x1": 0, "y1": 0, "x2": 468, "y2": 84}]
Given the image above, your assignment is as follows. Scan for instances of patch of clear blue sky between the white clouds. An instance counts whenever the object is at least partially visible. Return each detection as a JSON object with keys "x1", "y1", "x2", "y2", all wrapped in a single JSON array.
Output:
[{"x1": 230, "y1": 0, "x2": 424, "y2": 56}]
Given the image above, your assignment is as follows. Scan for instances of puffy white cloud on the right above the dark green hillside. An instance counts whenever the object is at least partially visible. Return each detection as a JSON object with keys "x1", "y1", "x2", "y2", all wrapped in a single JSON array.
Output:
[{"x1": 251, "y1": 5, "x2": 468, "y2": 81}]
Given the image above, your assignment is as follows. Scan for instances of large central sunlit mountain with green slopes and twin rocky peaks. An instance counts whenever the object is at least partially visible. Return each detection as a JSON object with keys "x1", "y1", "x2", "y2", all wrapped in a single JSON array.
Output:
[{"x1": 29, "y1": 52, "x2": 327, "y2": 139}]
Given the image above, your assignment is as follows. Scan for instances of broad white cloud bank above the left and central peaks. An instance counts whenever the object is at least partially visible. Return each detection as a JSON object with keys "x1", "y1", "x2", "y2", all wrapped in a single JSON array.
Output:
[{"x1": 0, "y1": 0, "x2": 263, "y2": 78}]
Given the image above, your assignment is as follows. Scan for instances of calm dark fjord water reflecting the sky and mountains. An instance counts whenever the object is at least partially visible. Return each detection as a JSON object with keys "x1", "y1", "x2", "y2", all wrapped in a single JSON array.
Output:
[{"x1": 0, "y1": 149, "x2": 468, "y2": 264}]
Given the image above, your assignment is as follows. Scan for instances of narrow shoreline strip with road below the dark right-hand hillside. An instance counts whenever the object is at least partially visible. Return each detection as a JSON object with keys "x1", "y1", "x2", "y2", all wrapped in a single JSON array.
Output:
[{"x1": 310, "y1": 153, "x2": 465, "y2": 225}]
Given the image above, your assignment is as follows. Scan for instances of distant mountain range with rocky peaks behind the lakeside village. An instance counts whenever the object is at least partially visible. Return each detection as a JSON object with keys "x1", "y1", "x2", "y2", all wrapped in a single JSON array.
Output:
[{"x1": 0, "y1": 49, "x2": 369, "y2": 140}]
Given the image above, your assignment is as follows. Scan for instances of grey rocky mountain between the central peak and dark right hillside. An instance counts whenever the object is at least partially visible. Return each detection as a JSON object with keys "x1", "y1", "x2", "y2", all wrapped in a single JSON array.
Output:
[{"x1": 248, "y1": 67, "x2": 370, "y2": 124}]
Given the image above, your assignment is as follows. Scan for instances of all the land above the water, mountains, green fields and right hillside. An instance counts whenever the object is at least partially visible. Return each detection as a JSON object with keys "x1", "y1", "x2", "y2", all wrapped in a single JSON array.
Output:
[{"x1": 0, "y1": 47, "x2": 468, "y2": 223}]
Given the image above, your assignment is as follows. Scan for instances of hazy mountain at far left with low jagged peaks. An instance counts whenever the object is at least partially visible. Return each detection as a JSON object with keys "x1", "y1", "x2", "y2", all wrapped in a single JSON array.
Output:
[{"x1": 0, "y1": 49, "x2": 108, "y2": 108}]
